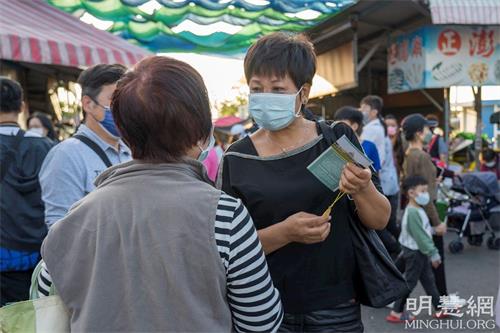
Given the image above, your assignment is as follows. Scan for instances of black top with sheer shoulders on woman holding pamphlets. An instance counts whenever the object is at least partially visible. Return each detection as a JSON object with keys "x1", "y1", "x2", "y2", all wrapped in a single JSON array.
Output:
[{"x1": 219, "y1": 123, "x2": 382, "y2": 313}]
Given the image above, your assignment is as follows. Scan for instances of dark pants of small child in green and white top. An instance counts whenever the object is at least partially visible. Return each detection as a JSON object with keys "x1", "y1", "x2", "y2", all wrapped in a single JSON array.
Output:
[{"x1": 394, "y1": 247, "x2": 439, "y2": 312}]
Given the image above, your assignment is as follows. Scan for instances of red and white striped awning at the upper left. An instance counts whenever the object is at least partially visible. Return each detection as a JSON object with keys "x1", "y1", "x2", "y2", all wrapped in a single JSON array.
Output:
[{"x1": 0, "y1": 0, "x2": 149, "y2": 67}]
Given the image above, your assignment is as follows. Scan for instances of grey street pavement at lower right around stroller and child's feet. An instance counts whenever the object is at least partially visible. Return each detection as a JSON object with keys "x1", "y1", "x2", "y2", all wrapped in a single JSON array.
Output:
[{"x1": 362, "y1": 232, "x2": 500, "y2": 333}]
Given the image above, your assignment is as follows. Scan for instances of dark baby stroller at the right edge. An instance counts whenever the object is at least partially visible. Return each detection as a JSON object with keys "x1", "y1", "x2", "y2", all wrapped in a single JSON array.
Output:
[{"x1": 440, "y1": 172, "x2": 500, "y2": 253}]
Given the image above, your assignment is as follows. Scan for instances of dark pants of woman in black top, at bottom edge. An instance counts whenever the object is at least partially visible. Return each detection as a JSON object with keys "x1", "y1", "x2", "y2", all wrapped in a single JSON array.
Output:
[{"x1": 278, "y1": 301, "x2": 364, "y2": 333}]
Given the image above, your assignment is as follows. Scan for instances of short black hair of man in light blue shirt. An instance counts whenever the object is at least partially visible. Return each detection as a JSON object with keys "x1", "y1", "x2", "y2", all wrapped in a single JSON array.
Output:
[{"x1": 78, "y1": 64, "x2": 127, "y2": 99}]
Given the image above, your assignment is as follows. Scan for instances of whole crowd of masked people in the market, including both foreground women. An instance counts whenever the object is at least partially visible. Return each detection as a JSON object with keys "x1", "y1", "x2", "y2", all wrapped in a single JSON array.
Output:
[{"x1": 0, "y1": 33, "x2": 498, "y2": 332}]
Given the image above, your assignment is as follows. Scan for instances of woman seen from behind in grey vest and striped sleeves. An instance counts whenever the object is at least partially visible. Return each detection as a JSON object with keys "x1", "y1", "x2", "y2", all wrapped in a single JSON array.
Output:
[{"x1": 38, "y1": 57, "x2": 283, "y2": 332}]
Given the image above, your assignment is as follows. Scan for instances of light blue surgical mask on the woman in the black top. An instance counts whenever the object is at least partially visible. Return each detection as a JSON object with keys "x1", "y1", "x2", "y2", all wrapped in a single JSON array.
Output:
[{"x1": 248, "y1": 88, "x2": 302, "y2": 131}]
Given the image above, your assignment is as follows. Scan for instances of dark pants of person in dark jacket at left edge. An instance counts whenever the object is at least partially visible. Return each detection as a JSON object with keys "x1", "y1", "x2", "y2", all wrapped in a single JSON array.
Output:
[{"x1": 0, "y1": 269, "x2": 33, "y2": 306}]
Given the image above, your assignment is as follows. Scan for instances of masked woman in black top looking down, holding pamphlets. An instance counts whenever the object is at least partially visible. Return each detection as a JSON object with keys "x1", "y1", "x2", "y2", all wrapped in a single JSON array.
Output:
[{"x1": 218, "y1": 33, "x2": 390, "y2": 332}]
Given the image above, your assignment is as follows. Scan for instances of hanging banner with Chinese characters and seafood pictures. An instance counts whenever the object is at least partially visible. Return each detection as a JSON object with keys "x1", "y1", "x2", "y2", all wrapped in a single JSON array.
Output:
[{"x1": 387, "y1": 25, "x2": 500, "y2": 93}]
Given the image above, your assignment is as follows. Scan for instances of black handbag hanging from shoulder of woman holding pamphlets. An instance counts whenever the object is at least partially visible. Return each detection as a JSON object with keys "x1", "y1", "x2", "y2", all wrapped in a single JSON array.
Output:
[{"x1": 319, "y1": 122, "x2": 410, "y2": 308}]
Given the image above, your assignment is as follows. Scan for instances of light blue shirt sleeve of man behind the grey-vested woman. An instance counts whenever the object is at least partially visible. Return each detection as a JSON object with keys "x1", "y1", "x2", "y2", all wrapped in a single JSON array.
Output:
[{"x1": 39, "y1": 146, "x2": 85, "y2": 227}]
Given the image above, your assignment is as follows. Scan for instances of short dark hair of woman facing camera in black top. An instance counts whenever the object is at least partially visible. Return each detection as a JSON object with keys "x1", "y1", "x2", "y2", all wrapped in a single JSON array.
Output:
[{"x1": 244, "y1": 32, "x2": 316, "y2": 89}]
